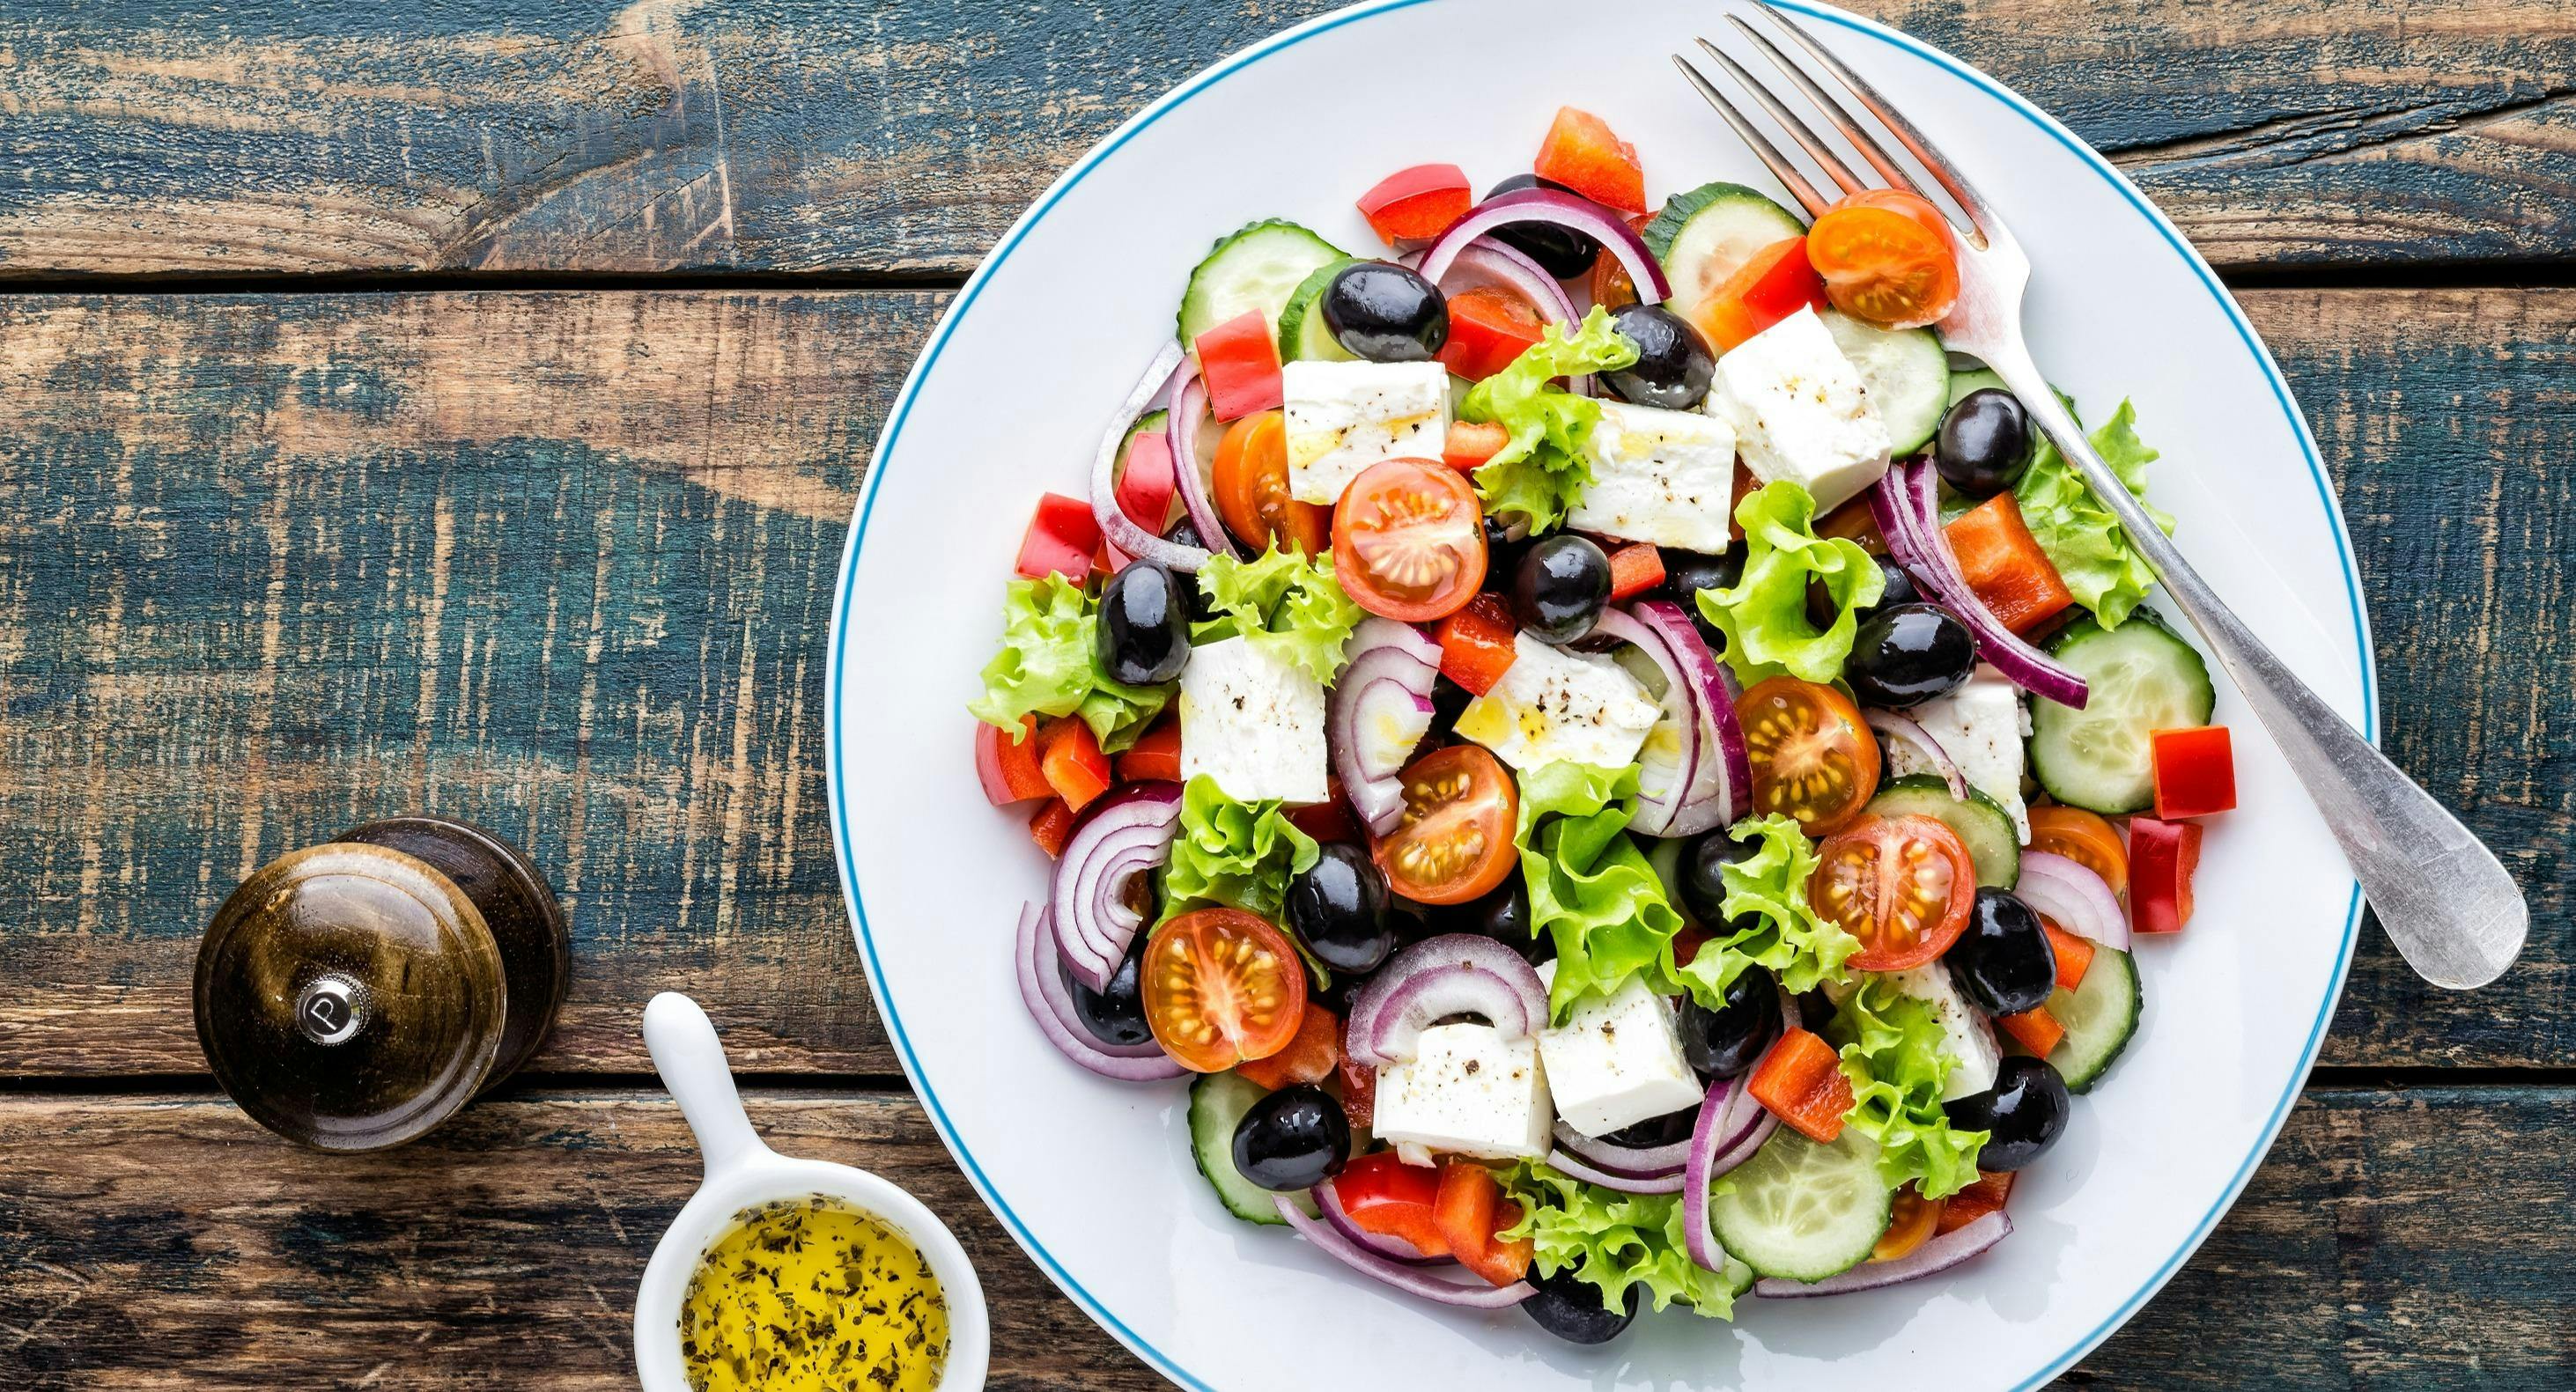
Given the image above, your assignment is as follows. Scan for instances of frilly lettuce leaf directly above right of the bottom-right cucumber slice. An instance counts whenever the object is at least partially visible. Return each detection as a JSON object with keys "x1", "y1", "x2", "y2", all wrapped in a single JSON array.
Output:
[{"x1": 1824, "y1": 976, "x2": 1986, "y2": 1199}]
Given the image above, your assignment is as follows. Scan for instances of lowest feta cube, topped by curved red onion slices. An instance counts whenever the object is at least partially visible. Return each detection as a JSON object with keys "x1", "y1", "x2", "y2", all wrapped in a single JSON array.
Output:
[{"x1": 1368, "y1": 1024, "x2": 1556, "y2": 1163}]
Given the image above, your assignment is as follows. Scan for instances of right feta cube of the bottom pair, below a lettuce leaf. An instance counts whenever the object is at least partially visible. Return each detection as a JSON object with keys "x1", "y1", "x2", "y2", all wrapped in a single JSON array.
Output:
[{"x1": 1538, "y1": 962, "x2": 1705, "y2": 1138}]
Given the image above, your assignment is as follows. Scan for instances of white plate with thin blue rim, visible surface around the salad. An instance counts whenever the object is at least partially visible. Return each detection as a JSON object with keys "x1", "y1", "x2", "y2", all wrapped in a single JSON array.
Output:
[{"x1": 827, "y1": 0, "x2": 2375, "y2": 1392}]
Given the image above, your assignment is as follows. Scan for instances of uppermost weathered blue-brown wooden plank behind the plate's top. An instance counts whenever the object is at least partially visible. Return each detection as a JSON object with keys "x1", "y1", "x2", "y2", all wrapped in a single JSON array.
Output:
[{"x1": 0, "y1": 0, "x2": 2576, "y2": 278}]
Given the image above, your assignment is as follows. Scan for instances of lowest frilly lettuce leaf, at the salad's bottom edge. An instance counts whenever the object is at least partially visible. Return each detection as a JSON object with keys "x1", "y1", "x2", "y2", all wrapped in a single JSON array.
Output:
[{"x1": 1499, "y1": 1160, "x2": 1752, "y2": 1320}]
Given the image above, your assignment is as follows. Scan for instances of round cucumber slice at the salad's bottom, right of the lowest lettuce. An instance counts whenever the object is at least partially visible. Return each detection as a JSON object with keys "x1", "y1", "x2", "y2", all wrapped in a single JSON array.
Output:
[{"x1": 1708, "y1": 1127, "x2": 1893, "y2": 1281}]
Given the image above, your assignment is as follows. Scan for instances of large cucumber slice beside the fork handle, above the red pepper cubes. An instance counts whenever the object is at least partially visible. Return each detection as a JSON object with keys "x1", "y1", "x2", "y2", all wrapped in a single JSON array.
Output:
[{"x1": 2030, "y1": 608, "x2": 2218, "y2": 815}]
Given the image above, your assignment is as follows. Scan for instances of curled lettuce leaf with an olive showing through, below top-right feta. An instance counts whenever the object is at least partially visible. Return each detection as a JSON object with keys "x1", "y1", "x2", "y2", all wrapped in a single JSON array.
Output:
[{"x1": 1701, "y1": 481, "x2": 1888, "y2": 684}]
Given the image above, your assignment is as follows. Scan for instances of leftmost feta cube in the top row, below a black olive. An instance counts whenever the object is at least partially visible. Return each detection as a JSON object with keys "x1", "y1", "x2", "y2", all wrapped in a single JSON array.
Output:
[{"x1": 1281, "y1": 360, "x2": 1448, "y2": 507}]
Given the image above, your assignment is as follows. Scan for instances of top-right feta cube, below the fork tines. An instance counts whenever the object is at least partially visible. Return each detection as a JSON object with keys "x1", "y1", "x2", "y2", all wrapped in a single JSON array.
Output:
[{"x1": 1708, "y1": 309, "x2": 1888, "y2": 514}]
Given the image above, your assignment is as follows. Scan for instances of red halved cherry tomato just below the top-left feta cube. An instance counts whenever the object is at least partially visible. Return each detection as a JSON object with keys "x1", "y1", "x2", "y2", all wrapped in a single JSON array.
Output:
[{"x1": 1332, "y1": 458, "x2": 1484, "y2": 622}]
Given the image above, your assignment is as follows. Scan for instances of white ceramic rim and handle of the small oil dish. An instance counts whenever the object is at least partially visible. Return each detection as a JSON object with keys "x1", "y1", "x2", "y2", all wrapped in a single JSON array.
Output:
[{"x1": 636, "y1": 991, "x2": 992, "y2": 1392}]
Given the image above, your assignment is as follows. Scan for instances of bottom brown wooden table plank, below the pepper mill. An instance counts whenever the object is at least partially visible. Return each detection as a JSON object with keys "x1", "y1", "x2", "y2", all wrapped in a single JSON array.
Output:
[{"x1": 0, "y1": 1088, "x2": 2576, "y2": 1392}]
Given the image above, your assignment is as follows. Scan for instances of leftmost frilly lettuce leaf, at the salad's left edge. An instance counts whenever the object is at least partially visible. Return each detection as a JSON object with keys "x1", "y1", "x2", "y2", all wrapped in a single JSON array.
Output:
[{"x1": 966, "y1": 574, "x2": 1172, "y2": 754}]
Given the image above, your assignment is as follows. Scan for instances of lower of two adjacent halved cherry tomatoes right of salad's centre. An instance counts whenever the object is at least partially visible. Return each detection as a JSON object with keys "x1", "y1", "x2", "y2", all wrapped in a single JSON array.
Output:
[{"x1": 1805, "y1": 815, "x2": 1975, "y2": 973}]
